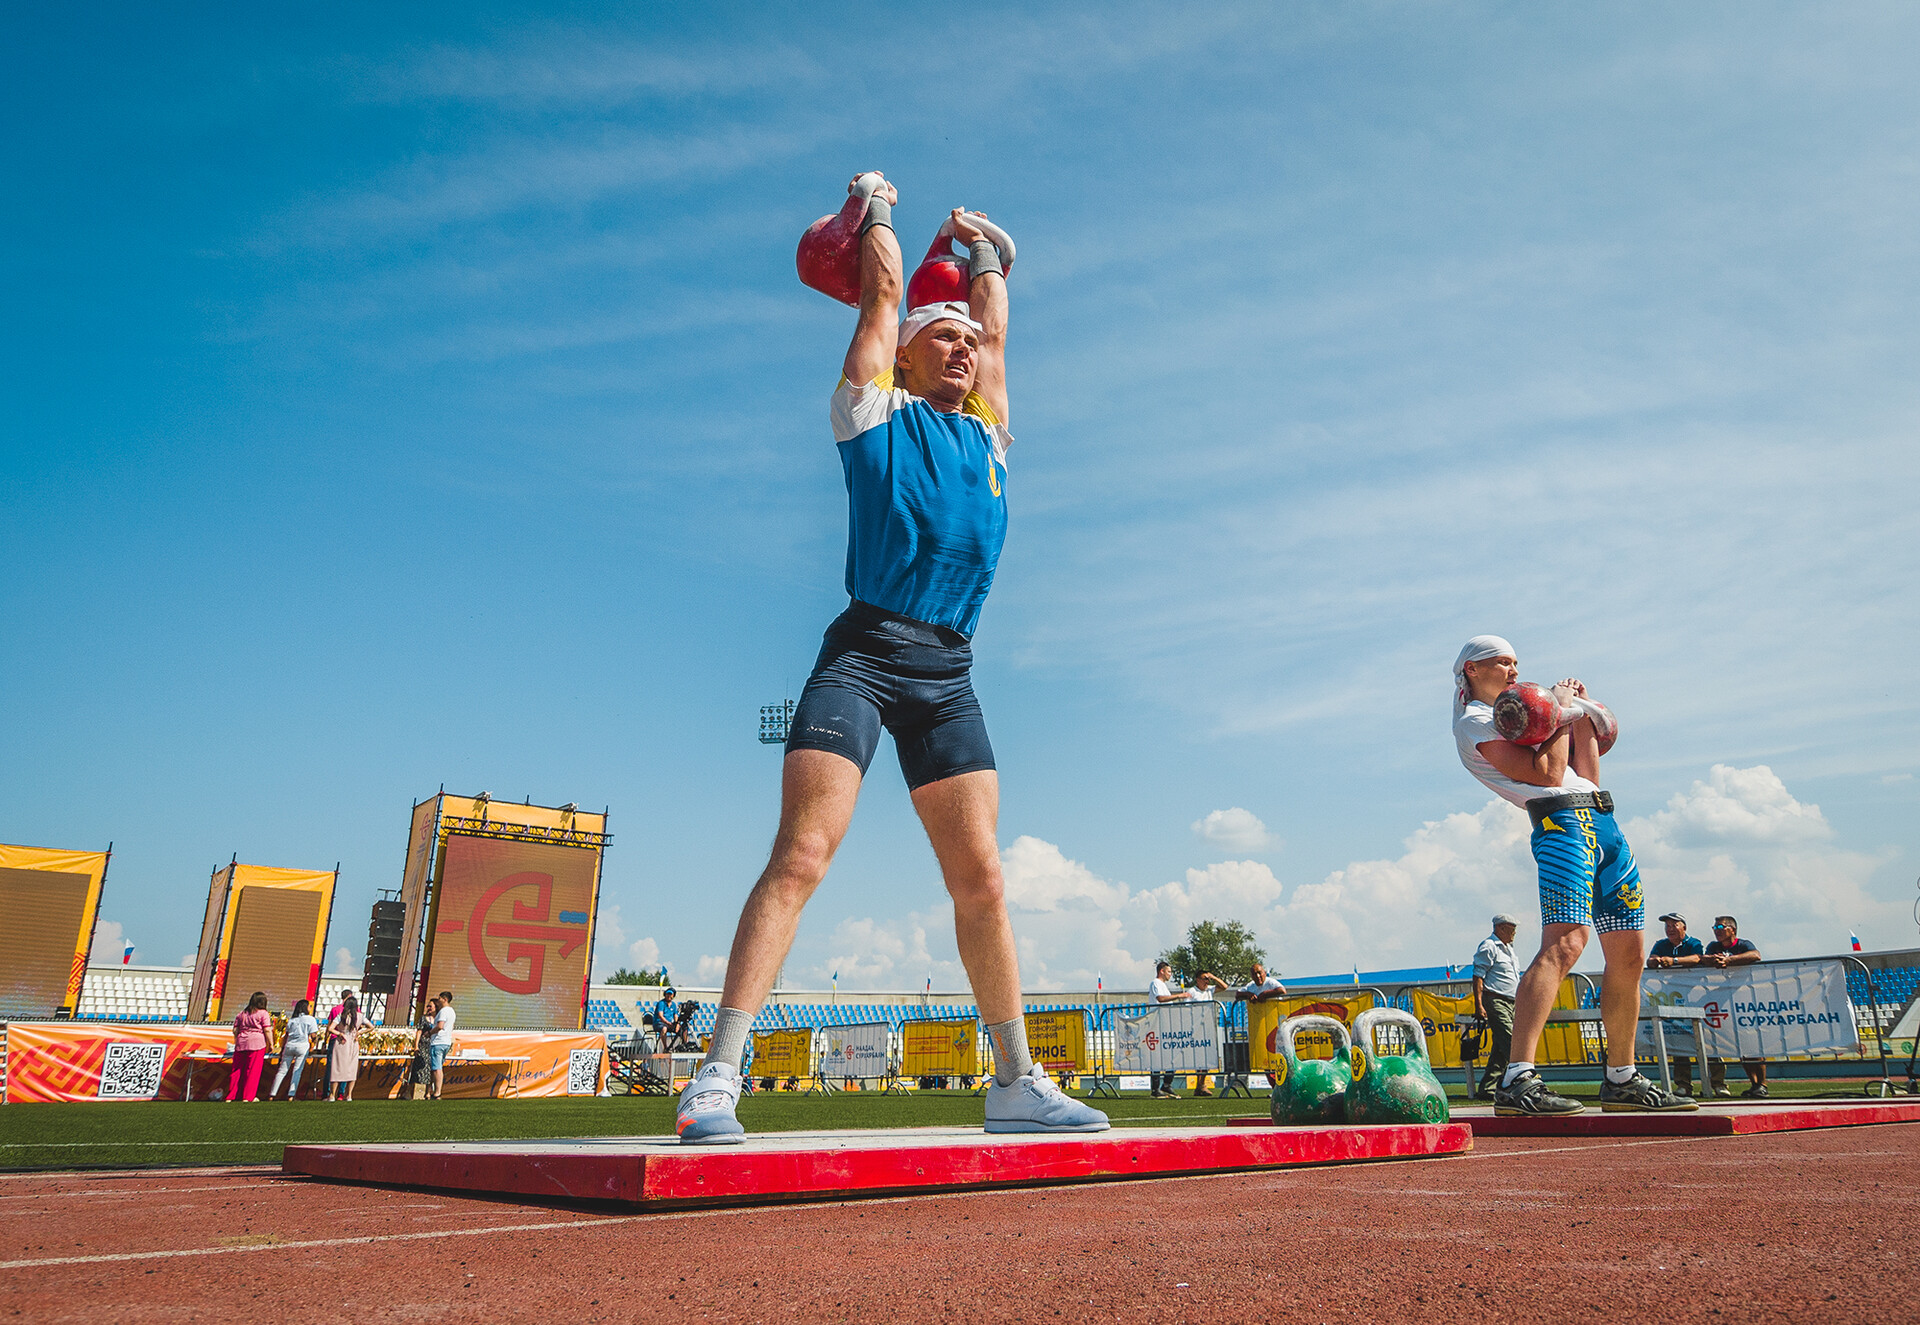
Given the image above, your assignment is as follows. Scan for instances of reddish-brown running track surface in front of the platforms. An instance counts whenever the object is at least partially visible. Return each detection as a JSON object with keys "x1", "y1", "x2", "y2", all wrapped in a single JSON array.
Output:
[{"x1": 0, "y1": 1125, "x2": 1920, "y2": 1325}]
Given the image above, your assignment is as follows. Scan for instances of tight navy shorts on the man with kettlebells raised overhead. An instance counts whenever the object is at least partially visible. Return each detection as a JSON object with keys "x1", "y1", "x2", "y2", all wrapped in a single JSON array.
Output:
[{"x1": 787, "y1": 601, "x2": 993, "y2": 791}]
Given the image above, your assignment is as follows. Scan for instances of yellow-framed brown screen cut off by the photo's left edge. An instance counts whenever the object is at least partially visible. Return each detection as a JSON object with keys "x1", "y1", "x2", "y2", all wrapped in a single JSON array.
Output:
[{"x1": 0, "y1": 843, "x2": 108, "y2": 1020}]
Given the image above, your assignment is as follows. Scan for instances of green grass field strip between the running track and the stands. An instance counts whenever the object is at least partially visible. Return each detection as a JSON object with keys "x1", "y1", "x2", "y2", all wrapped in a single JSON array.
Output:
[{"x1": 0, "y1": 1072, "x2": 1889, "y2": 1171}]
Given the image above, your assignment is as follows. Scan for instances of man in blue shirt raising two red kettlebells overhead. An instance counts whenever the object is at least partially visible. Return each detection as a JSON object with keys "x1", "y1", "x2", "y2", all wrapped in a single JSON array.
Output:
[{"x1": 676, "y1": 177, "x2": 1108, "y2": 1143}]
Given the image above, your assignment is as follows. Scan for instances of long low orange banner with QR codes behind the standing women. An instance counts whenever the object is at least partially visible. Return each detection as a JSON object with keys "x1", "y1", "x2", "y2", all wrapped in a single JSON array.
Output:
[{"x1": 6, "y1": 1022, "x2": 607, "y2": 1104}]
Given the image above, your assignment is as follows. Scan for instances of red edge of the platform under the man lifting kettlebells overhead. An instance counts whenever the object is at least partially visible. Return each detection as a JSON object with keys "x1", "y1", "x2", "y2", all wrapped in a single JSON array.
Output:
[{"x1": 280, "y1": 1123, "x2": 1473, "y2": 1206}]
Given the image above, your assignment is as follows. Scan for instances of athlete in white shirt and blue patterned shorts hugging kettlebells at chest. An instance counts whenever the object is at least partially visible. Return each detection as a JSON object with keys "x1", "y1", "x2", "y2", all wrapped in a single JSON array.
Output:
[{"x1": 1453, "y1": 636, "x2": 1699, "y2": 1116}]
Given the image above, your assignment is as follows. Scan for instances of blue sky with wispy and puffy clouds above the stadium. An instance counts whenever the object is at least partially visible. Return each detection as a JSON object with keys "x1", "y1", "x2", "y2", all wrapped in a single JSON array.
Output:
[{"x1": 0, "y1": 4, "x2": 1920, "y2": 987}]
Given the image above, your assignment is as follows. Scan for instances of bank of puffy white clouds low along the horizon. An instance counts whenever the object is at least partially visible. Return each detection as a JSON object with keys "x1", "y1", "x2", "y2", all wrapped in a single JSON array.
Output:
[{"x1": 794, "y1": 764, "x2": 1905, "y2": 991}]
